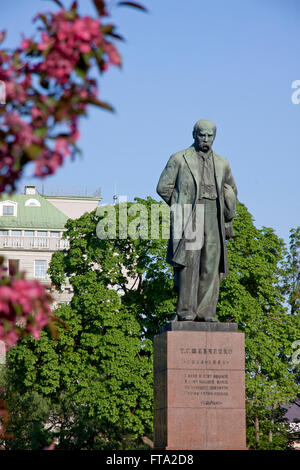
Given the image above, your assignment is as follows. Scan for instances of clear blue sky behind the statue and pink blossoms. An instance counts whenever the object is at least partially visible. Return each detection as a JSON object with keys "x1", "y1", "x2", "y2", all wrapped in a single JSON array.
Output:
[{"x1": 0, "y1": 0, "x2": 300, "y2": 241}]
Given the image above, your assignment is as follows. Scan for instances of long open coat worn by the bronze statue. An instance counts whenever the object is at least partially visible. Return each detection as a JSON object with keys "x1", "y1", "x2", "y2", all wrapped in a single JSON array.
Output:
[{"x1": 157, "y1": 145, "x2": 237, "y2": 279}]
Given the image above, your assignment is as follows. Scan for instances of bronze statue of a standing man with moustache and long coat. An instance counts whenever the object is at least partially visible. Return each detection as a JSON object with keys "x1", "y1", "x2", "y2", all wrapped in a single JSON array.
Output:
[{"x1": 157, "y1": 119, "x2": 237, "y2": 321}]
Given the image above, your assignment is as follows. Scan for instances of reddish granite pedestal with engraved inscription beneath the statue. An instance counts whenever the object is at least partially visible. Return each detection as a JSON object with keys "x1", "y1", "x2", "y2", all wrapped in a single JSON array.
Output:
[{"x1": 154, "y1": 321, "x2": 246, "y2": 450}]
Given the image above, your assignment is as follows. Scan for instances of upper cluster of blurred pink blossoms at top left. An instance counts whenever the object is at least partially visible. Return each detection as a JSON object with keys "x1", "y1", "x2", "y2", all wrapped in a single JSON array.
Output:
[{"x1": 0, "y1": 2, "x2": 121, "y2": 196}]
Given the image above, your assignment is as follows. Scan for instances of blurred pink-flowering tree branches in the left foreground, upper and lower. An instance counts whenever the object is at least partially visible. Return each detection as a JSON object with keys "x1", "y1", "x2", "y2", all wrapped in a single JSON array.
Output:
[{"x1": 0, "y1": 0, "x2": 145, "y2": 345}]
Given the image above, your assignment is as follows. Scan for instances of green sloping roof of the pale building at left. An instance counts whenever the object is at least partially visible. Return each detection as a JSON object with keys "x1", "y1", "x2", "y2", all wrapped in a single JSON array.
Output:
[{"x1": 0, "y1": 194, "x2": 68, "y2": 229}]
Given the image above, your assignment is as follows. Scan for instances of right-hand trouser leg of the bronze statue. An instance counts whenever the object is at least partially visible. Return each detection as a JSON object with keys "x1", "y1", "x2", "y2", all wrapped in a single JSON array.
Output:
[{"x1": 197, "y1": 199, "x2": 221, "y2": 320}]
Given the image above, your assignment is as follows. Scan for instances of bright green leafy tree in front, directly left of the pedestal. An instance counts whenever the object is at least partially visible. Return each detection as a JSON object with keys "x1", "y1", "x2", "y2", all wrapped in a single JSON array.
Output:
[{"x1": 4, "y1": 209, "x2": 153, "y2": 449}]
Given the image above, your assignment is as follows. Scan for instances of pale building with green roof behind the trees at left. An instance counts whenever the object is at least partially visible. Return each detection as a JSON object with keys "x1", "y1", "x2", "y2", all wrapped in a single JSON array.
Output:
[{"x1": 0, "y1": 185, "x2": 101, "y2": 307}]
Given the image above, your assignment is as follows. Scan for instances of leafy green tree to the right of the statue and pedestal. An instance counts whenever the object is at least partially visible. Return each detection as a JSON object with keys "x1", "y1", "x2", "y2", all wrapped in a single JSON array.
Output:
[{"x1": 218, "y1": 203, "x2": 300, "y2": 449}]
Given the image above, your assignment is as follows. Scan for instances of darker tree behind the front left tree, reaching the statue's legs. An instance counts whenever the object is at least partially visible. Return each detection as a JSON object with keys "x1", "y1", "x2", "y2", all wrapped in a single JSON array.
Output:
[{"x1": 50, "y1": 197, "x2": 176, "y2": 339}]
